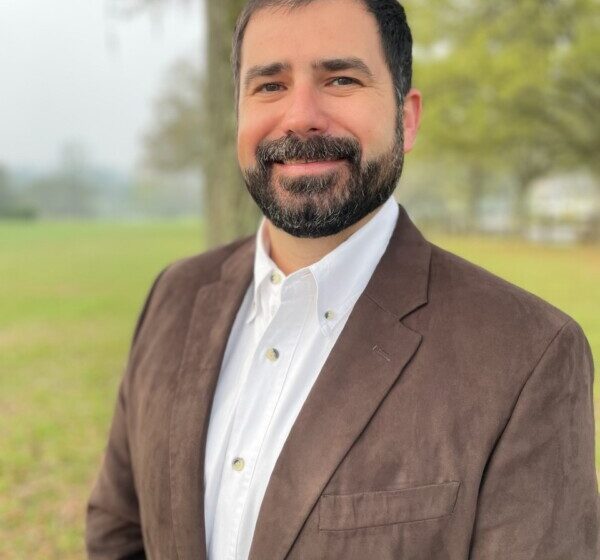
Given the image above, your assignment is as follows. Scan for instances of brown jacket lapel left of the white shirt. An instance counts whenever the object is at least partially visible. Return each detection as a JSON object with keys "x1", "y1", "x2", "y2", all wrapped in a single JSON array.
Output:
[{"x1": 169, "y1": 238, "x2": 255, "y2": 560}]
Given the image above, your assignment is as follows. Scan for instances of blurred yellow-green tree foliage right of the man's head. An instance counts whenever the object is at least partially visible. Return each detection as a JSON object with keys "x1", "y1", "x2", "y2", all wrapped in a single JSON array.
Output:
[{"x1": 409, "y1": 0, "x2": 600, "y2": 230}]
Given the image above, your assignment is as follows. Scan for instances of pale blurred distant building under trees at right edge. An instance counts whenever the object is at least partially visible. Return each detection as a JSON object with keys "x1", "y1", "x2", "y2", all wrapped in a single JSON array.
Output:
[{"x1": 526, "y1": 173, "x2": 600, "y2": 244}]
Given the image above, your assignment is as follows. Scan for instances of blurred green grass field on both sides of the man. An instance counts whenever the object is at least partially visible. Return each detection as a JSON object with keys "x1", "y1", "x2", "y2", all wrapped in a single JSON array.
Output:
[{"x1": 0, "y1": 222, "x2": 600, "y2": 560}]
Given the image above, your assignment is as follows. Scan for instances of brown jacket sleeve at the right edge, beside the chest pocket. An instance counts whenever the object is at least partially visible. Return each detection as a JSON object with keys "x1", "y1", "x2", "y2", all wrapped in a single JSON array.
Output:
[{"x1": 469, "y1": 321, "x2": 600, "y2": 560}]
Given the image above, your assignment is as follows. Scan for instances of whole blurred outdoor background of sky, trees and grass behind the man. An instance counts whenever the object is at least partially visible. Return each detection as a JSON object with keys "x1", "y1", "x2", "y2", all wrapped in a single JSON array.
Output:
[{"x1": 0, "y1": 0, "x2": 600, "y2": 559}]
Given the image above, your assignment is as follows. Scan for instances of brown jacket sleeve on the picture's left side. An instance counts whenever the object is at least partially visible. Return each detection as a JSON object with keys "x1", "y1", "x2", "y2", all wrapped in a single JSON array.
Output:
[{"x1": 86, "y1": 271, "x2": 164, "y2": 560}]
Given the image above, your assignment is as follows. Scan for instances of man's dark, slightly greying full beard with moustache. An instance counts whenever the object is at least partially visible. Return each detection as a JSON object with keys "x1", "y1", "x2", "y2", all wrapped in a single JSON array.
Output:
[{"x1": 242, "y1": 109, "x2": 404, "y2": 238}]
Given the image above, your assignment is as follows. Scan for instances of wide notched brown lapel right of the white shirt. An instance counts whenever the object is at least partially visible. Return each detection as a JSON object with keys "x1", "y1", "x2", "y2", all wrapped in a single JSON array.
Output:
[{"x1": 250, "y1": 207, "x2": 430, "y2": 560}]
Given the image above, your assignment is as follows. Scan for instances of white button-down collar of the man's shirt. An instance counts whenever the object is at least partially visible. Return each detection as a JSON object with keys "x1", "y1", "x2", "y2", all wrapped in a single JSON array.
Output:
[{"x1": 246, "y1": 196, "x2": 399, "y2": 334}]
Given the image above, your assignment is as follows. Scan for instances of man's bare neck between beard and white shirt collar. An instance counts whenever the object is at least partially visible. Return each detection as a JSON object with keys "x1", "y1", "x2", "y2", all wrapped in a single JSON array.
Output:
[{"x1": 265, "y1": 206, "x2": 381, "y2": 276}]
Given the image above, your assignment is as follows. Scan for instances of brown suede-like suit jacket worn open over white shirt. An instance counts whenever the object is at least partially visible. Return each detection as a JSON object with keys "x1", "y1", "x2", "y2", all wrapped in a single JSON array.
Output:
[{"x1": 87, "y1": 208, "x2": 600, "y2": 560}]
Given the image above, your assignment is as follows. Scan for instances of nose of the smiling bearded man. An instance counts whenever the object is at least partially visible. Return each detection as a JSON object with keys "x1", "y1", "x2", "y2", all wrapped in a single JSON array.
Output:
[{"x1": 281, "y1": 84, "x2": 329, "y2": 137}]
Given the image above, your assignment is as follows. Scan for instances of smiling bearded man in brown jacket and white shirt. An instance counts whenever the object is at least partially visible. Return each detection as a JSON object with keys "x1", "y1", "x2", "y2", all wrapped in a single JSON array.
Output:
[{"x1": 87, "y1": 0, "x2": 600, "y2": 560}]
